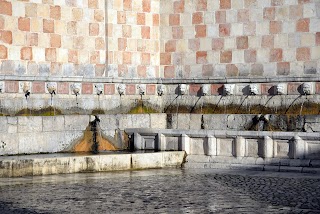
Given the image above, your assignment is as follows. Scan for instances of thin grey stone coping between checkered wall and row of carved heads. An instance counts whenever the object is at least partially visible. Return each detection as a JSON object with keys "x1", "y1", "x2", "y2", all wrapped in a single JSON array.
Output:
[{"x1": 0, "y1": 75, "x2": 320, "y2": 84}]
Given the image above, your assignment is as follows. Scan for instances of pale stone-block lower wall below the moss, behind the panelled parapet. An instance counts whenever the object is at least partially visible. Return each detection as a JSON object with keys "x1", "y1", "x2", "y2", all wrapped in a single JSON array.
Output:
[{"x1": 0, "y1": 114, "x2": 320, "y2": 155}]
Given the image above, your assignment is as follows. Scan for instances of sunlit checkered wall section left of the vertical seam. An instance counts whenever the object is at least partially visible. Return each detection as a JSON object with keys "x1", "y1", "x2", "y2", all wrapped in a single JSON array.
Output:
[{"x1": 0, "y1": 0, "x2": 106, "y2": 77}]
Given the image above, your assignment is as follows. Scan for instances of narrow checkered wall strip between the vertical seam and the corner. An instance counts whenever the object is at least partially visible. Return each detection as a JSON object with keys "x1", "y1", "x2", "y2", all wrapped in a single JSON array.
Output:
[{"x1": 106, "y1": 0, "x2": 160, "y2": 78}]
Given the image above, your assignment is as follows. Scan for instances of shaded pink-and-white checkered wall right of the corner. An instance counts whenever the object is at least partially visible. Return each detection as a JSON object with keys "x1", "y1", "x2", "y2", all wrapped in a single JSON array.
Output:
[{"x1": 160, "y1": 0, "x2": 320, "y2": 78}]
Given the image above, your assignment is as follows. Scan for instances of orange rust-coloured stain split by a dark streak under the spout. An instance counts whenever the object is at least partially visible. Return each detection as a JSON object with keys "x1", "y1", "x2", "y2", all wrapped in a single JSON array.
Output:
[{"x1": 72, "y1": 128, "x2": 117, "y2": 152}]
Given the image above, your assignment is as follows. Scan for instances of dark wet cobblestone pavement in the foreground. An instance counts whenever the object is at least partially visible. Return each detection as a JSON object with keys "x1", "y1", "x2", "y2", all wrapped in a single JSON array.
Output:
[{"x1": 0, "y1": 169, "x2": 320, "y2": 214}]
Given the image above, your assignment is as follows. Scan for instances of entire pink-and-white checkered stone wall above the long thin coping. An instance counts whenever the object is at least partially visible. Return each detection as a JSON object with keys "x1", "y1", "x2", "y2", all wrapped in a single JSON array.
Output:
[{"x1": 0, "y1": 0, "x2": 320, "y2": 78}]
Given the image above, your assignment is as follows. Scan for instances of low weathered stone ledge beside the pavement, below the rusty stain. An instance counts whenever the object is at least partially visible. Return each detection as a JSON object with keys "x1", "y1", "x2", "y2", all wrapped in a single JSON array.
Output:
[{"x1": 0, "y1": 151, "x2": 185, "y2": 177}]
